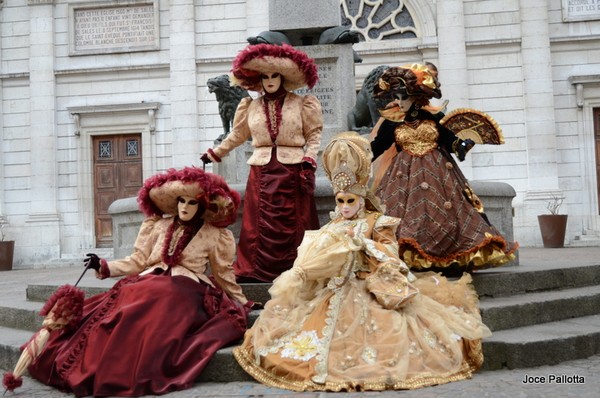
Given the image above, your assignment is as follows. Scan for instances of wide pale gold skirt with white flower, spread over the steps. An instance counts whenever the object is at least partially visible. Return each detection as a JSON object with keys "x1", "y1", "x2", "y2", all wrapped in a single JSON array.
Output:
[{"x1": 234, "y1": 272, "x2": 491, "y2": 391}]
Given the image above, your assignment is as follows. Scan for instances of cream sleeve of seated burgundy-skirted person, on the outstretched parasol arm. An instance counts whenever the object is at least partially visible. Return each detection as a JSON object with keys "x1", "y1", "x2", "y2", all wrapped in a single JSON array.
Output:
[{"x1": 108, "y1": 217, "x2": 160, "y2": 277}]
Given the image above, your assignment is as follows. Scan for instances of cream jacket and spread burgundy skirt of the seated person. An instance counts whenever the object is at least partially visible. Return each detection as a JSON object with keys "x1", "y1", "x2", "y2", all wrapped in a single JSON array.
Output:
[{"x1": 28, "y1": 219, "x2": 247, "y2": 397}]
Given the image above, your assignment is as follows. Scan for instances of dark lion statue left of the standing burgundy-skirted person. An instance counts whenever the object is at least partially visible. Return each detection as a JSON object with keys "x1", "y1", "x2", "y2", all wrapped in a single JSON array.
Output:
[{"x1": 206, "y1": 75, "x2": 250, "y2": 143}]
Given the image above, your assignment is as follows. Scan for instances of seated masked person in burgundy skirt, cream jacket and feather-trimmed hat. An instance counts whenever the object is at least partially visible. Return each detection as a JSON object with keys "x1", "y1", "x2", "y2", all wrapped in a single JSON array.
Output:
[{"x1": 28, "y1": 167, "x2": 254, "y2": 397}]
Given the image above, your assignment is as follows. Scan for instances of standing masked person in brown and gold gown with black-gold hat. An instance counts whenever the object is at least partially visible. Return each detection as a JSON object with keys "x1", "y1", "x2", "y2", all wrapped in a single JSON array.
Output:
[{"x1": 371, "y1": 64, "x2": 518, "y2": 275}]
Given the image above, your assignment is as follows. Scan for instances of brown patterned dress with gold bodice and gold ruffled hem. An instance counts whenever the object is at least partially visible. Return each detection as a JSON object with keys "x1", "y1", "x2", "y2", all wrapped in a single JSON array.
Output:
[{"x1": 373, "y1": 120, "x2": 518, "y2": 272}]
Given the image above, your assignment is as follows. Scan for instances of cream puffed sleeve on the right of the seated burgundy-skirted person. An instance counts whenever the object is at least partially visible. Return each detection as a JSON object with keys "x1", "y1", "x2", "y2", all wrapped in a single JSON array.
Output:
[{"x1": 208, "y1": 228, "x2": 248, "y2": 305}]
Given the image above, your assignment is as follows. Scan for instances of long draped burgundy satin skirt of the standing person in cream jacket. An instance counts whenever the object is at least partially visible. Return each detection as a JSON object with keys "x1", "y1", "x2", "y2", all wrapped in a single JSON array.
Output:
[{"x1": 233, "y1": 147, "x2": 319, "y2": 282}]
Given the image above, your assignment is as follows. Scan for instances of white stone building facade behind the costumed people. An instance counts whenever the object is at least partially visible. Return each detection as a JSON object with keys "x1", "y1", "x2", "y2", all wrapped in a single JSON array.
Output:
[{"x1": 0, "y1": 0, "x2": 600, "y2": 268}]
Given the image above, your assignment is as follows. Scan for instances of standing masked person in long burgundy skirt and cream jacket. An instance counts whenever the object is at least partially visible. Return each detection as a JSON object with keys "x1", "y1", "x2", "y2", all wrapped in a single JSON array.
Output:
[{"x1": 201, "y1": 44, "x2": 323, "y2": 282}]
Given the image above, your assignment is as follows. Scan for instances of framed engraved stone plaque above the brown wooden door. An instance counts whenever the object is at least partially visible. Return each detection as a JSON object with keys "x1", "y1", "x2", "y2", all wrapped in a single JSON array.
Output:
[{"x1": 69, "y1": 0, "x2": 160, "y2": 55}]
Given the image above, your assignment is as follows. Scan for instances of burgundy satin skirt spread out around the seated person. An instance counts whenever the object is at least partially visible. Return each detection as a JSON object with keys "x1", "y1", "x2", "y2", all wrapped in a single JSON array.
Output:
[{"x1": 28, "y1": 275, "x2": 247, "y2": 397}]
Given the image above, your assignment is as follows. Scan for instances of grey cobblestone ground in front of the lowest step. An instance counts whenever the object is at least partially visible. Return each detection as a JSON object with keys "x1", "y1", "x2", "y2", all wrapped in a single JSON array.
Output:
[{"x1": 5, "y1": 355, "x2": 600, "y2": 398}]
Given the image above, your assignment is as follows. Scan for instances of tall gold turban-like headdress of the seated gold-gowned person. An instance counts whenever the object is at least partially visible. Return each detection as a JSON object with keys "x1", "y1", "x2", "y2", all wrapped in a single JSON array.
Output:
[{"x1": 323, "y1": 131, "x2": 382, "y2": 212}]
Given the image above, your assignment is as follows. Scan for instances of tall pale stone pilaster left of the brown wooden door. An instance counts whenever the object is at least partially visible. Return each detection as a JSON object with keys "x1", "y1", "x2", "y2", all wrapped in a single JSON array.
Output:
[{"x1": 25, "y1": 0, "x2": 60, "y2": 261}]
